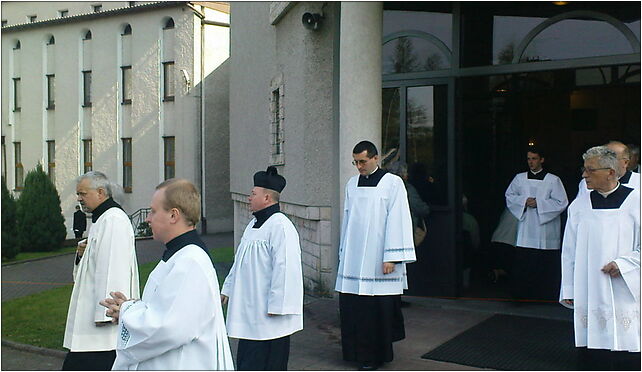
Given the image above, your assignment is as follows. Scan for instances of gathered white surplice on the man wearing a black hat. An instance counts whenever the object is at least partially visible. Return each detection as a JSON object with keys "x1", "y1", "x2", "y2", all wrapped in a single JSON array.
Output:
[{"x1": 221, "y1": 212, "x2": 303, "y2": 340}]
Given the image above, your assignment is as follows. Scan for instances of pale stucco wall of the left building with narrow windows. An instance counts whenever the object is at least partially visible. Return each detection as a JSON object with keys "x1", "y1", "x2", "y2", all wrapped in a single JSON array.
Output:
[{"x1": 2, "y1": 3, "x2": 229, "y2": 237}]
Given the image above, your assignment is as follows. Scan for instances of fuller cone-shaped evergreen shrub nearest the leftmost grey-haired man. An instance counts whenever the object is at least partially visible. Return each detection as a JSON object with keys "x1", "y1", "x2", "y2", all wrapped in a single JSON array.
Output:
[{"x1": 18, "y1": 164, "x2": 66, "y2": 252}]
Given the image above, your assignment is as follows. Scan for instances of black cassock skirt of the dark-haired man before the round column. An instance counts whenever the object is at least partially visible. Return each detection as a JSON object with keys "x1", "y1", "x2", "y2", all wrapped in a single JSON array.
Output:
[{"x1": 339, "y1": 293, "x2": 406, "y2": 363}]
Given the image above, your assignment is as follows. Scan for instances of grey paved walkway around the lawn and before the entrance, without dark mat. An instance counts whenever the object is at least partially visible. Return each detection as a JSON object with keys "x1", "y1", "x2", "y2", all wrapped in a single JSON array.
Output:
[{"x1": 2, "y1": 234, "x2": 570, "y2": 370}]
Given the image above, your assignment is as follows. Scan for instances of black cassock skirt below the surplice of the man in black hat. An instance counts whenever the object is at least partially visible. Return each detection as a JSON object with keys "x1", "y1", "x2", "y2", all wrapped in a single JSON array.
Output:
[{"x1": 236, "y1": 336, "x2": 290, "y2": 371}]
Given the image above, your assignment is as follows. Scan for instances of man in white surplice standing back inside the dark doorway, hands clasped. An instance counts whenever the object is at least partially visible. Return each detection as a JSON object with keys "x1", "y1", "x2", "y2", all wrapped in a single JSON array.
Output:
[{"x1": 505, "y1": 147, "x2": 568, "y2": 299}]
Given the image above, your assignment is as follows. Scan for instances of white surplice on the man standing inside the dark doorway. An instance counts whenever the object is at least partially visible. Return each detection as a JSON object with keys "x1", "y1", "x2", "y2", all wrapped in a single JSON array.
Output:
[{"x1": 505, "y1": 172, "x2": 568, "y2": 249}]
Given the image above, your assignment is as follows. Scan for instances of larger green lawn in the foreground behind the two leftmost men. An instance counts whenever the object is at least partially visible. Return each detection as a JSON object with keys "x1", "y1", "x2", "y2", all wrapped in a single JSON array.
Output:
[{"x1": 2, "y1": 247, "x2": 234, "y2": 350}]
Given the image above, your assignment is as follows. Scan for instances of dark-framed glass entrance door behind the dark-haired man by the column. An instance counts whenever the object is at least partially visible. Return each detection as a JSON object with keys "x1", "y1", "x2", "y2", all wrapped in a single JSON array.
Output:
[{"x1": 381, "y1": 79, "x2": 457, "y2": 296}]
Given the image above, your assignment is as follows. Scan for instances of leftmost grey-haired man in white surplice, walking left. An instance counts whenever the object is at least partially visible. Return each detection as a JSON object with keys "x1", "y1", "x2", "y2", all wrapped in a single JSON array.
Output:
[{"x1": 62, "y1": 171, "x2": 139, "y2": 370}]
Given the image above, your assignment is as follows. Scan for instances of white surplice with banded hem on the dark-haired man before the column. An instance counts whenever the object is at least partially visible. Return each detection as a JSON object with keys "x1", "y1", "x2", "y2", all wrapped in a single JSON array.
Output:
[{"x1": 335, "y1": 173, "x2": 416, "y2": 296}]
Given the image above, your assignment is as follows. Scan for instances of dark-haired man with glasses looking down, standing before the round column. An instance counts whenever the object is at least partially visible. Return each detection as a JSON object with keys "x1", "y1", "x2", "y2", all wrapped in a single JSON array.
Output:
[{"x1": 335, "y1": 141, "x2": 415, "y2": 370}]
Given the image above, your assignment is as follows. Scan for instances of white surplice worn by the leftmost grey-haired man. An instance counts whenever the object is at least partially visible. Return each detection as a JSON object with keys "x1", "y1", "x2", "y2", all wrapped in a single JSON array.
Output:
[{"x1": 63, "y1": 207, "x2": 139, "y2": 352}]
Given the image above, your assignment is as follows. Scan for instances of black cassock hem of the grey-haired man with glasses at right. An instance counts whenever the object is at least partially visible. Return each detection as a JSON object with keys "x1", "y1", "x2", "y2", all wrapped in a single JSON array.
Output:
[{"x1": 577, "y1": 347, "x2": 640, "y2": 371}]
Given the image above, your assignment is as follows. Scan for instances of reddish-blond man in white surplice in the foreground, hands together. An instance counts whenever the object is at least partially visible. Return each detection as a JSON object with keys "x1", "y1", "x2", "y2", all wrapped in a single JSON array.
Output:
[{"x1": 101, "y1": 178, "x2": 234, "y2": 370}]
